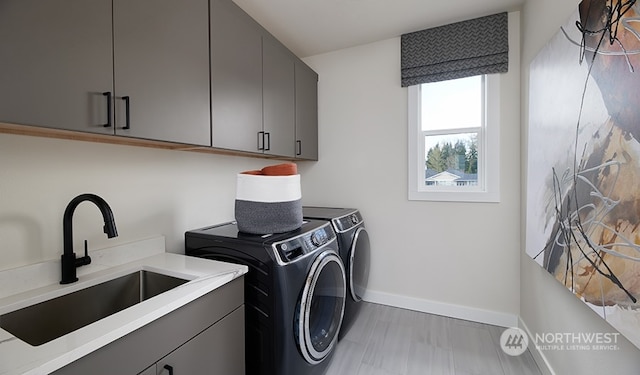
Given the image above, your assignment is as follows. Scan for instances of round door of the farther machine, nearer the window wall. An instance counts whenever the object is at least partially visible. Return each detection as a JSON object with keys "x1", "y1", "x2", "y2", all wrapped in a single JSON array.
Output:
[{"x1": 349, "y1": 228, "x2": 370, "y2": 302}]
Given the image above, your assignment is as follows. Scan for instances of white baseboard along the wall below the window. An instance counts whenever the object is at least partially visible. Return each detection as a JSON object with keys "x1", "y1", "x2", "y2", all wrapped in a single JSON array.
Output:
[{"x1": 363, "y1": 290, "x2": 519, "y2": 327}]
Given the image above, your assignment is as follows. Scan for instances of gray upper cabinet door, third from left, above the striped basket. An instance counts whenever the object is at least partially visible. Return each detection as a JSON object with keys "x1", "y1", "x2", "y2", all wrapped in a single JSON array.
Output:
[{"x1": 211, "y1": 0, "x2": 262, "y2": 152}]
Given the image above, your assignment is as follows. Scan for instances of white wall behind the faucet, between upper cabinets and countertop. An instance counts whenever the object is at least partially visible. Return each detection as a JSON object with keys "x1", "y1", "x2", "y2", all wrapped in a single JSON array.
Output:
[{"x1": 0, "y1": 134, "x2": 273, "y2": 270}]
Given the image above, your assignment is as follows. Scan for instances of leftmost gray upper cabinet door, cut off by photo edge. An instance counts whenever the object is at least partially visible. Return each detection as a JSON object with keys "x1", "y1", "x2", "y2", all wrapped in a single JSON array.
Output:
[{"x1": 0, "y1": 0, "x2": 113, "y2": 133}]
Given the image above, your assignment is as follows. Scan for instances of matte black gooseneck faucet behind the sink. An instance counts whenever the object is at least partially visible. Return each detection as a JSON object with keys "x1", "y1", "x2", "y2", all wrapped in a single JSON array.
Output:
[{"x1": 60, "y1": 194, "x2": 118, "y2": 284}]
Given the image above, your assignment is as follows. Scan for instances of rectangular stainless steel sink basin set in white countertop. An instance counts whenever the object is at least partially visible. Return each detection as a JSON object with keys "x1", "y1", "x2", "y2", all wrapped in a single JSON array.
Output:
[{"x1": 0, "y1": 271, "x2": 188, "y2": 346}]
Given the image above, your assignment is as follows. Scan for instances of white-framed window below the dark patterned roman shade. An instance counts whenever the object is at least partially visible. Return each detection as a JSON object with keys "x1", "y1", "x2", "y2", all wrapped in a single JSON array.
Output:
[{"x1": 409, "y1": 74, "x2": 500, "y2": 202}]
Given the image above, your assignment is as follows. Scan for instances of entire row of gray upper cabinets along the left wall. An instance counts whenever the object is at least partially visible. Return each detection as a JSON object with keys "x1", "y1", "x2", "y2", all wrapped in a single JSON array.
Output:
[{"x1": 0, "y1": 0, "x2": 318, "y2": 160}]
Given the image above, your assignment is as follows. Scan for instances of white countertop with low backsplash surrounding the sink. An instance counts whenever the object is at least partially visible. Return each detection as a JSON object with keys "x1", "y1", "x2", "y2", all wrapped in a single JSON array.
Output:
[{"x1": 0, "y1": 237, "x2": 248, "y2": 375}]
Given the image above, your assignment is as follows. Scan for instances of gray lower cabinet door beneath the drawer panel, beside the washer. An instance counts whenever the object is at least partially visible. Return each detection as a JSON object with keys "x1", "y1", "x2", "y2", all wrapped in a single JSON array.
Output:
[{"x1": 156, "y1": 305, "x2": 245, "y2": 375}]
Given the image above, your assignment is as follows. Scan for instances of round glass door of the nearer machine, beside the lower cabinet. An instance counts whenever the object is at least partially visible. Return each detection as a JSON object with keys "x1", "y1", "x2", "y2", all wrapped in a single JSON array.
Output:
[{"x1": 296, "y1": 250, "x2": 346, "y2": 364}]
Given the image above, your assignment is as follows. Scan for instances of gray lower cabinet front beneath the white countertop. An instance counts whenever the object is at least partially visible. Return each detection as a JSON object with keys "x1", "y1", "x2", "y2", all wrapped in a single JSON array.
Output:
[{"x1": 53, "y1": 277, "x2": 245, "y2": 375}]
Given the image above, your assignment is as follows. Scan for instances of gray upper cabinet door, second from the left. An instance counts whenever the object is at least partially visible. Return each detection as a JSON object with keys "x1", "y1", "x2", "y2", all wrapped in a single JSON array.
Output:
[{"x1": 113, "y1": 0, "x2": 211, "y2": 146}]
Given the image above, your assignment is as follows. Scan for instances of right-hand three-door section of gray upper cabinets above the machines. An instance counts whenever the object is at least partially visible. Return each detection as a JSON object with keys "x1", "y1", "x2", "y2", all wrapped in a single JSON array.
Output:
[{"x1": 211, "y1": 0, "x2": 318, "y2": 160}]
